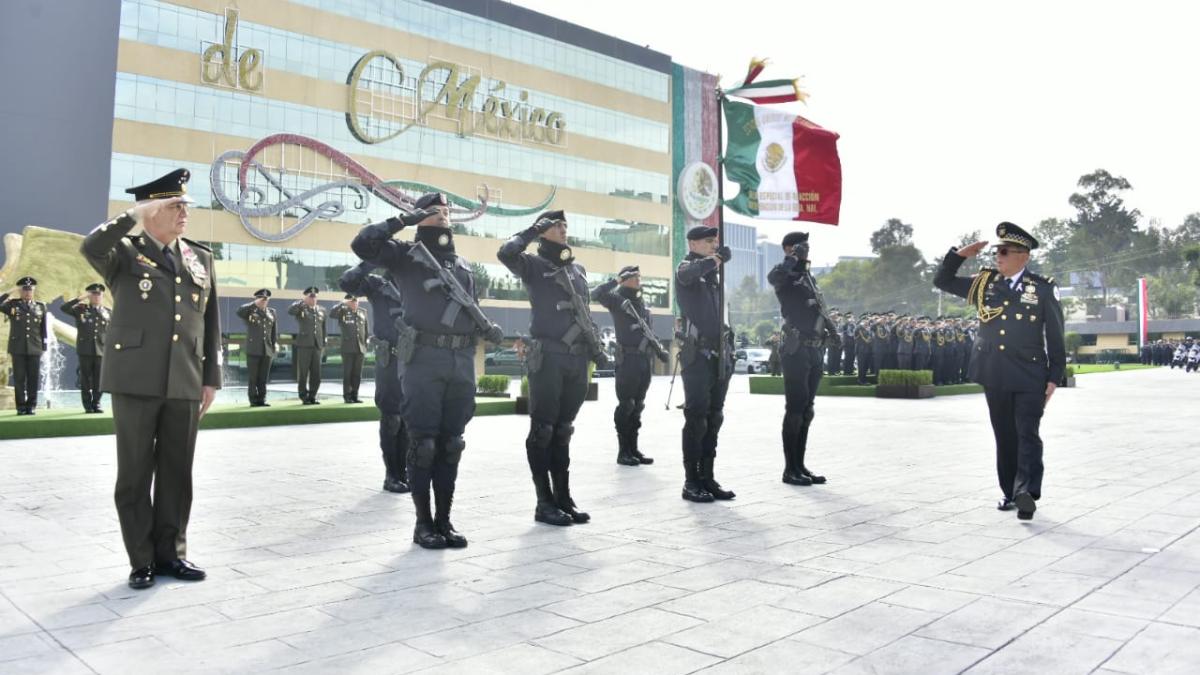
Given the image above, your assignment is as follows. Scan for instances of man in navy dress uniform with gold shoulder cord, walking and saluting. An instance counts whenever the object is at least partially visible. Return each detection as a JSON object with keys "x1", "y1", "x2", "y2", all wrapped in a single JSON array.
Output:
[{"x1": 934, "y1": 222, "x2": 1067, "y2": 520}]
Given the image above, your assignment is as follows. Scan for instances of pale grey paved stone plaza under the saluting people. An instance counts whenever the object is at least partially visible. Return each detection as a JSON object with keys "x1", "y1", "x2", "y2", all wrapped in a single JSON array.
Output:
[{"x1": 0, "y1": 370, "x2": 1200, "y2": 675}]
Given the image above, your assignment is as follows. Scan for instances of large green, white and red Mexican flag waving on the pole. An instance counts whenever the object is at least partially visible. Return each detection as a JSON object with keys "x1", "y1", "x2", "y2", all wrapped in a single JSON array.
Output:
[{"x1": 721, "y1": 98, "x2": 841, "y2": 225}]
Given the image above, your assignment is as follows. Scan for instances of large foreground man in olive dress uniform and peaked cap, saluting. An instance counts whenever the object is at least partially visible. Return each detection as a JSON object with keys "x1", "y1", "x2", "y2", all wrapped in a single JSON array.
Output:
[{"x1": 82, "y1": 169, "x2": 221, "y2": 589}]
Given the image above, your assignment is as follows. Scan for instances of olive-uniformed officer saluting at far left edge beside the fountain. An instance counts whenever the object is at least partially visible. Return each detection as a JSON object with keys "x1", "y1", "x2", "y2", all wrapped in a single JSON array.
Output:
[{"x1": 0, "y1": 276, "x2": 48, "y2": 414}]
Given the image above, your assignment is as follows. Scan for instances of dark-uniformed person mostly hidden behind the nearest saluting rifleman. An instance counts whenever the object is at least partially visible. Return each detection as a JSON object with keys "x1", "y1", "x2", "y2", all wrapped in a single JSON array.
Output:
[{"x1": 337, "y1": 263, "x2": 409, "y2": 492}]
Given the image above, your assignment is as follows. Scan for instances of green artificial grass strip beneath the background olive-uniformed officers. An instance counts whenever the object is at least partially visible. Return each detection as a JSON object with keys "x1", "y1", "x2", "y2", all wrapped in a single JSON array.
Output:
[{"x1": 0, "y1": 398, "x2": 516, "y2": 440}]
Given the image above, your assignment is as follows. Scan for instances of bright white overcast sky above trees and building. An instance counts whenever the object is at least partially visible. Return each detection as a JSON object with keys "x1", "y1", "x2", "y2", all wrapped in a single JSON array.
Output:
[{"x1": 516, "y1": 0, "x2": 1200, "y2": 264}]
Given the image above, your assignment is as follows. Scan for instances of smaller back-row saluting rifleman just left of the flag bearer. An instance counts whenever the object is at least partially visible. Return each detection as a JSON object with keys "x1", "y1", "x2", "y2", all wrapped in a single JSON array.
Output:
[{"x1": 592, "y1": 265, "x2": 668, "y2": 466}]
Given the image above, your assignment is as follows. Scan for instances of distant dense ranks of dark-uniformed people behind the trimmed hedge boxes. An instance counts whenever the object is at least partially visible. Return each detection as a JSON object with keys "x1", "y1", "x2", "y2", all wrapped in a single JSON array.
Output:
[{"x1": 772, "y1": 309, "x2": 979, "y2": 384}]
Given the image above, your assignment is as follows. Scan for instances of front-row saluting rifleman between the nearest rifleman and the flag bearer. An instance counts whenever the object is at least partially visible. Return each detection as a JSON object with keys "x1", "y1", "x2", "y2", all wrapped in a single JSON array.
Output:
[{"x1": 497, "y1": 211, "x2": 601, "y2": 525}]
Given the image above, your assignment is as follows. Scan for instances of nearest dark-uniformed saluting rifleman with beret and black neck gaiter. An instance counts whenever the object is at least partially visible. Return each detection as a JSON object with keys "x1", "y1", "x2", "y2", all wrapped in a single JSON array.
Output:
[{"x1": 350, "y1": 192, "x2": 499, "y2": 549}]
